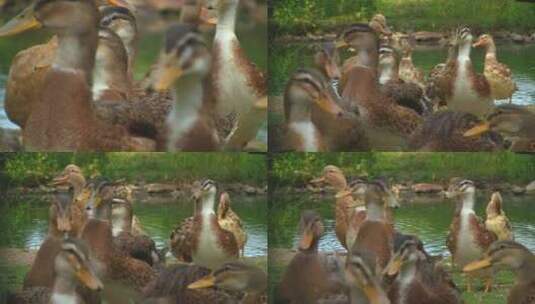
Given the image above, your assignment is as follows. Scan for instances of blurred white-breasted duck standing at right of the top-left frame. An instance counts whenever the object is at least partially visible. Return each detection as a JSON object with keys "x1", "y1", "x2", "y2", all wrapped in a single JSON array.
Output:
[{"x1": 206, "y1": 0, "x2": 267, "y2": 142}]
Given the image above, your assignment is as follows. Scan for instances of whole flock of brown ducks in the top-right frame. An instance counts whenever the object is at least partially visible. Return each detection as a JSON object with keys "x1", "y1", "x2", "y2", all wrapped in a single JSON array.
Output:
[{"x1": 279, "y1": 14, "x2": 535, "y2": 152}]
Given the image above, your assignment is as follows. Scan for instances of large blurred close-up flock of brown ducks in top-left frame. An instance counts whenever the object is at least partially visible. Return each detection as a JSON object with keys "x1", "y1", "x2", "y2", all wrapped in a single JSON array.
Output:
[{"x1": 0, "y1": 0, "x2": 267, "y2": 151}]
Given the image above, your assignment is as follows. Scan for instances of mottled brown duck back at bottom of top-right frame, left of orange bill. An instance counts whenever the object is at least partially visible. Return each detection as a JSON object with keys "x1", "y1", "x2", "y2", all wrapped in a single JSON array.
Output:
[{"x1": 409, "y1": 110, "x2": 505, "y2": 152}]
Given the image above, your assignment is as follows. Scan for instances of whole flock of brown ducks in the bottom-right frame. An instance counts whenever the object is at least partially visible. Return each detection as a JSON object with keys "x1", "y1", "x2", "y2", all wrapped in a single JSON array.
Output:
[{"x1": 277, "y1": 165, "x2": 535, "y2": 304}]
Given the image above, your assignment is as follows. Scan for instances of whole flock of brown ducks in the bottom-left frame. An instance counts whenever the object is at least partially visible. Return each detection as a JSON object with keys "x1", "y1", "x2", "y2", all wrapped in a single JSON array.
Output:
[{"x1": 8, "y1": 165, "x2": 267, "y2": 304}]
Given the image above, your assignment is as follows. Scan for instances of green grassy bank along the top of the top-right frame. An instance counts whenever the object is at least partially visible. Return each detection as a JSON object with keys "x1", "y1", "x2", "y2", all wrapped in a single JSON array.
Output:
[{"x1": 272, "y1": 0, "x2": 535, "y2": 35}]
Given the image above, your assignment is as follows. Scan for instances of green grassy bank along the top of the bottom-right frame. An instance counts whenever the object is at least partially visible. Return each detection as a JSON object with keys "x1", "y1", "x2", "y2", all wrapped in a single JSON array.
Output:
[{"x1": 270, "y1": 152, "x2": 535, "y2": 187}]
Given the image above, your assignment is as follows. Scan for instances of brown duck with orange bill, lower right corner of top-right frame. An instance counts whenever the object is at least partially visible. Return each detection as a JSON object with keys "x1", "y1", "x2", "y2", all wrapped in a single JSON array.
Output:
[{"x1": 464, "y1": 104, "x2": 535, "y2": 152}]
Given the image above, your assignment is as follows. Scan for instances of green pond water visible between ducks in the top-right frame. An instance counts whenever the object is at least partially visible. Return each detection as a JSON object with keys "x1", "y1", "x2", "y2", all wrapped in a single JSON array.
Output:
[{"x1": 269, "y1": 44, "x2": 535, "y2": 104}]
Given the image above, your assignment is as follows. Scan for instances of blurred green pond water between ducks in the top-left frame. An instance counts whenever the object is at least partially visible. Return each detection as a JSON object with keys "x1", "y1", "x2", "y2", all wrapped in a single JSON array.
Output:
[{"x1": 0, "y1": 19, "x2": 267, "y2": 144}]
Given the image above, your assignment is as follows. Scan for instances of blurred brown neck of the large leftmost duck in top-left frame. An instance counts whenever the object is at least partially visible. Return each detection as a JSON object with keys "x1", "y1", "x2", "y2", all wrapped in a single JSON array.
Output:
[{"x1": 53, "y1": 28, "x2": 98, "y2": 85}]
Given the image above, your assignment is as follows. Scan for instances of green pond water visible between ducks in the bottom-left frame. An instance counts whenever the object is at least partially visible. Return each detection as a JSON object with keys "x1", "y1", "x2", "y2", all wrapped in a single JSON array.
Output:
[{"x1": 0, "y1": 192, "x2": 267, "y2": 294}]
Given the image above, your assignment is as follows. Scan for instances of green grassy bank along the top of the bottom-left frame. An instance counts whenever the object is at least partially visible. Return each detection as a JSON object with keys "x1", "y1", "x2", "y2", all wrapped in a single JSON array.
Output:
[{"x1": 0, "y1": 153, "x2": 266, "y2": 187}]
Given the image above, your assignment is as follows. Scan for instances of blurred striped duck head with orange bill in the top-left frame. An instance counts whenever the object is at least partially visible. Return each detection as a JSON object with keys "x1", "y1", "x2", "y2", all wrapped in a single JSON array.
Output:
[{"x1": 151, "y1": 25, "x2": 212, "y2": 91}]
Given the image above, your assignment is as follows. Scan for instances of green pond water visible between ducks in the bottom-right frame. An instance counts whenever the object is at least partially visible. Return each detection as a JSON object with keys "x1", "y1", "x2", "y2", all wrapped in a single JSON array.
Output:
[{"x1": 269, "y1": 194, "x2": 535, "y2": 303}]
